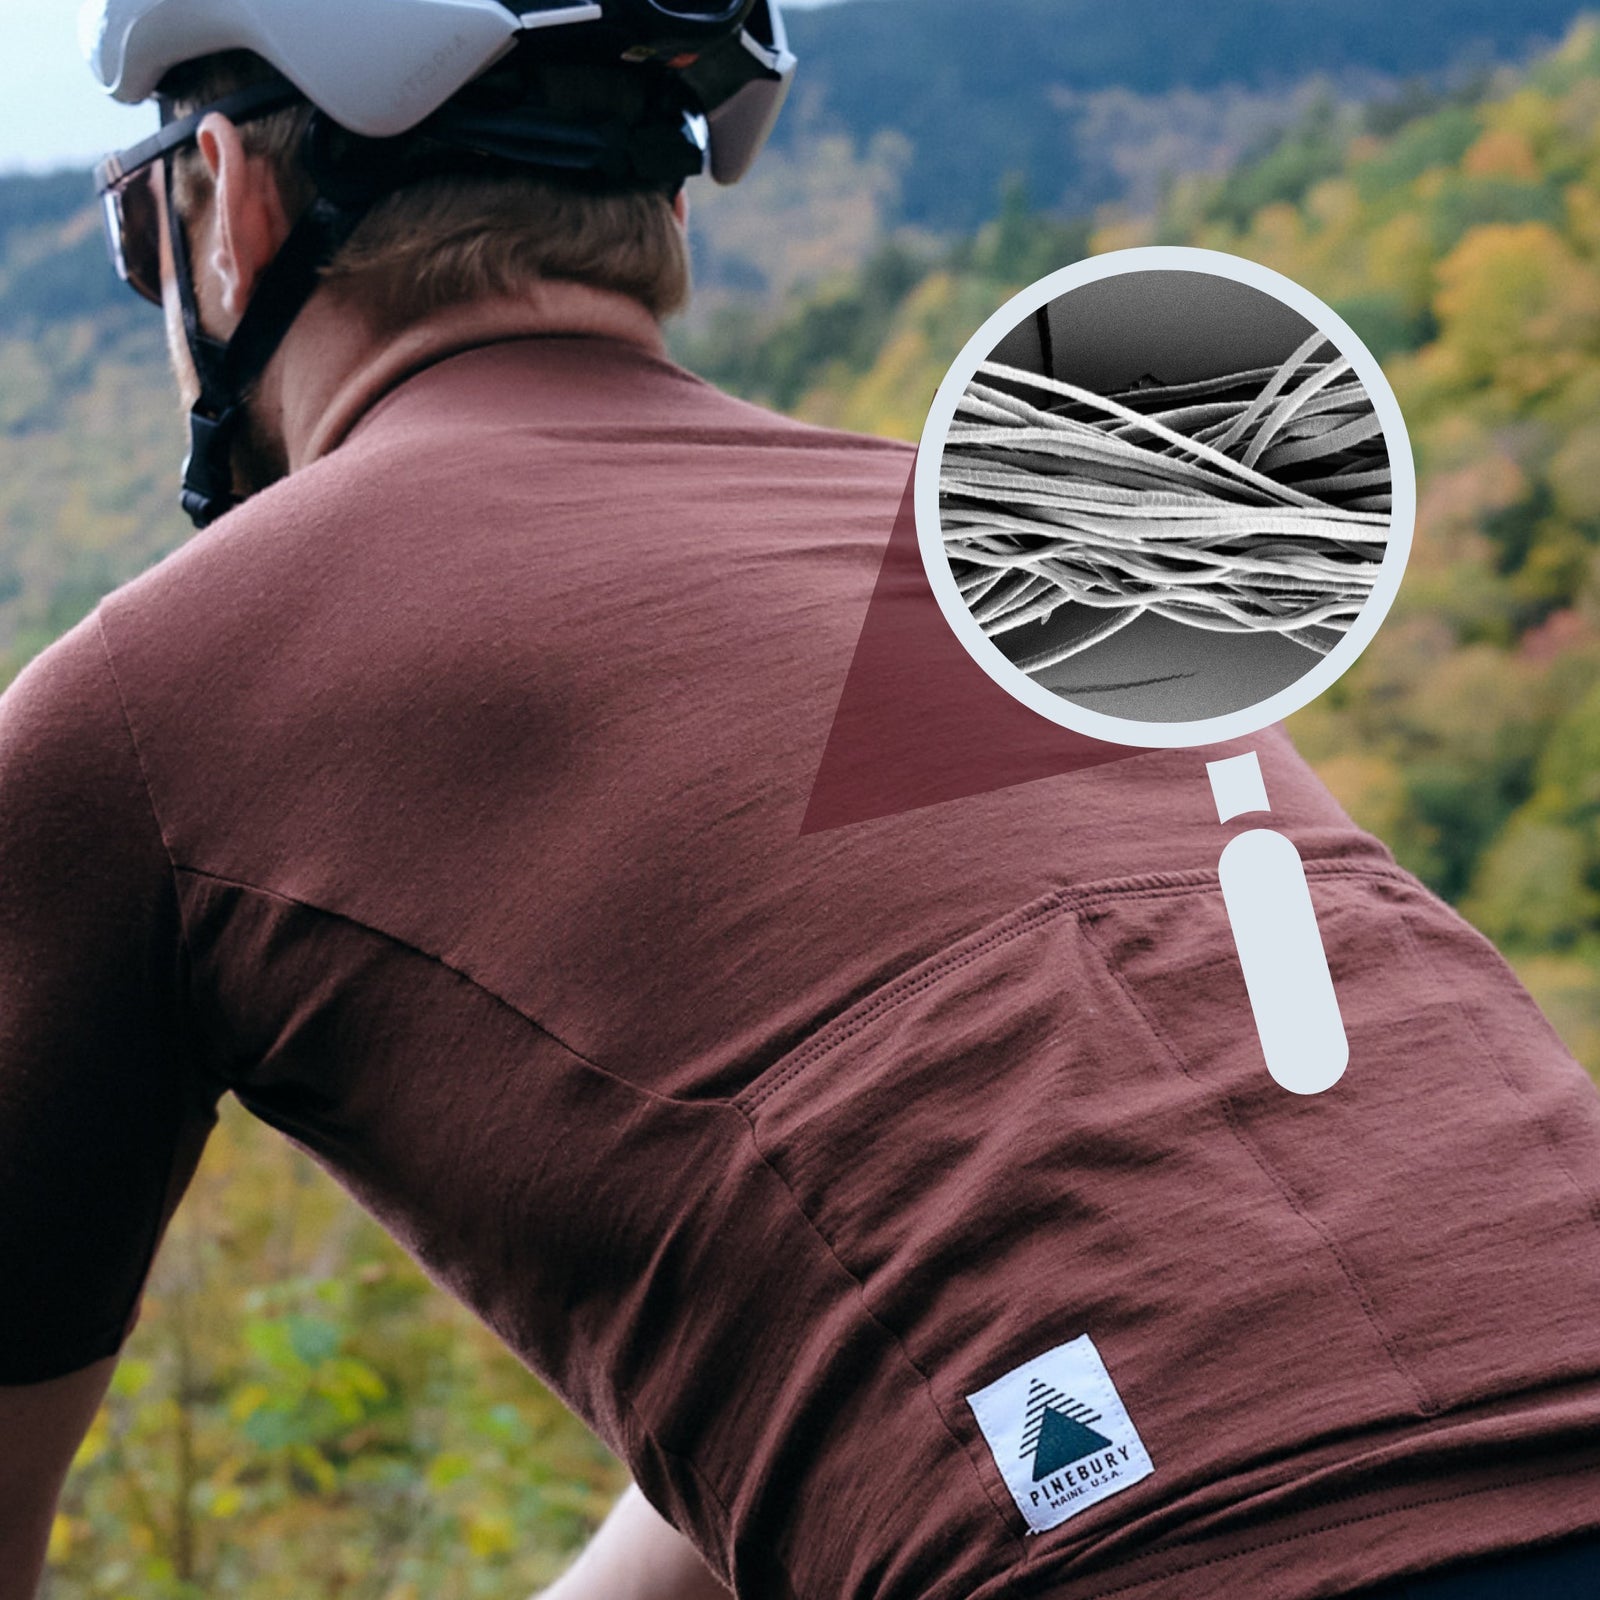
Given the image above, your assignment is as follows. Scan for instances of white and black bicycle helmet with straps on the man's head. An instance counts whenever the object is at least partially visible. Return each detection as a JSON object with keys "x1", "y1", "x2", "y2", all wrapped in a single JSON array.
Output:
[{"x1": 80, "y1": 0, "x2": 795, "y2": 526}]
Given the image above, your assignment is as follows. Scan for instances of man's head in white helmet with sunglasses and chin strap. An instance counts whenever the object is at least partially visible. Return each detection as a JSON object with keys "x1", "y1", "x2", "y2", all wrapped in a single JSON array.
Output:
[{"x1": 86, "y1": 0, "x2": 794, "y2": 523}]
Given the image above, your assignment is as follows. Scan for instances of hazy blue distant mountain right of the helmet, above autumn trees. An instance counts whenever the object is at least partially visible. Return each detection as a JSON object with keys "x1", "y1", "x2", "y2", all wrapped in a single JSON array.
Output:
[{"x1": 778, "y1": 0, "x2": 1579, "y2": 232}]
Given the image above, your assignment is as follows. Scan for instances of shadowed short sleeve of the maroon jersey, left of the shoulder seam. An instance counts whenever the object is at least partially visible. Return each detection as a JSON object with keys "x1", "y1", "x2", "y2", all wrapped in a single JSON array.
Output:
[{"x1": 0, "y1": 618, "x2": 216, "y2": 1384}]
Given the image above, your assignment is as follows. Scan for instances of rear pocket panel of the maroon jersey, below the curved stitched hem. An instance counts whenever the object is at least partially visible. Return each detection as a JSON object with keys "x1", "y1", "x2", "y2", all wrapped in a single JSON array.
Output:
[{"x1": 738, "y1": 862, "x2": 1555, "y2": 1536}]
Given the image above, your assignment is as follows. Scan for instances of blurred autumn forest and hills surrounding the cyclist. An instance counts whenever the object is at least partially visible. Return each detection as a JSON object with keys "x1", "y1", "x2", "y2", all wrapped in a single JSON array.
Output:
[{"x1": 9, "y1": 0, "x2": 1600, "y2": 1600}]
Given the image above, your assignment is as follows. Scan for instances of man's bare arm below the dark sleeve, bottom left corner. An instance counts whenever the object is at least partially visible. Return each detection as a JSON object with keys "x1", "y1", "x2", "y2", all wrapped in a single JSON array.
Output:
[{"x1": 0, "y1": 1355, "x2": 117, "y2": 1600}]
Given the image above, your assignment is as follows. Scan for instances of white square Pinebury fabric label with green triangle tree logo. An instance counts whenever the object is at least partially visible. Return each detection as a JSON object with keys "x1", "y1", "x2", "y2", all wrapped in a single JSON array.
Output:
[{"x1": 966, "y1": 1334, "x2": 1155, "y2": 1533}]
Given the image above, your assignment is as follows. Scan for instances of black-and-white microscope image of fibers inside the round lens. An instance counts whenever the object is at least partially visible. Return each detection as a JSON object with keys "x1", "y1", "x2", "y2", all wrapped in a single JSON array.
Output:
[{"x1": 939, "y1": 272, "x2": 1390, "y2": 722}]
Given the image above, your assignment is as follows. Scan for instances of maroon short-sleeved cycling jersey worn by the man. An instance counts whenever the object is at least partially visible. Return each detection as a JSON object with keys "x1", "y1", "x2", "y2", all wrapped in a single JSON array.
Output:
[{"x1": 0, "y1": 312, "x2": 1600, "y2": 1600}]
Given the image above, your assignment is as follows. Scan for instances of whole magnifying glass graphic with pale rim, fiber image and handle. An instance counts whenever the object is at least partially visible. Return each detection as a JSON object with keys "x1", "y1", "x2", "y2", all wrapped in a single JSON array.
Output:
[{"x1": 914, "y1": 246, "x2": 1416, "y2": 1094}]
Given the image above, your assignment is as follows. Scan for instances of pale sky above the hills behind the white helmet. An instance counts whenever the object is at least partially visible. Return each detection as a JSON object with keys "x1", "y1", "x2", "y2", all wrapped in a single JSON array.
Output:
[{"x1": 0, "y1": 0, "x2": 851, "y2": 173}]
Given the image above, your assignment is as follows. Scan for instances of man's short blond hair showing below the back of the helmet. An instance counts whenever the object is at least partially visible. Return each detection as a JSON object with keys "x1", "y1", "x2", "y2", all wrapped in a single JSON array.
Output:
[{"x1": 162, "y1": 50, "x2": 690, "y2": 326}]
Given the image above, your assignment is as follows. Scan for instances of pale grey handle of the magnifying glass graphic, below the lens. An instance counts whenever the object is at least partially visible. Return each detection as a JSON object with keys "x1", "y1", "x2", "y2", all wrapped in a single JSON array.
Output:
[{"x1": 1208, "y1": 750, "x2": 1350, "y2": 1094}]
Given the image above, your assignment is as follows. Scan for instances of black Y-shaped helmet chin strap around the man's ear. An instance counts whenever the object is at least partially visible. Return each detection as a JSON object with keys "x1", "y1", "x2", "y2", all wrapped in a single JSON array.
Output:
[{"x1": 162, "y1": 146, "x2": 370, "y2": 528}]
